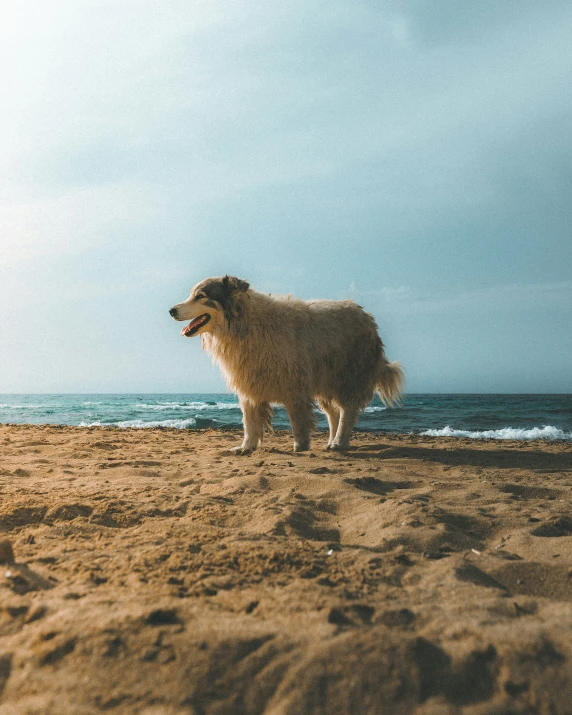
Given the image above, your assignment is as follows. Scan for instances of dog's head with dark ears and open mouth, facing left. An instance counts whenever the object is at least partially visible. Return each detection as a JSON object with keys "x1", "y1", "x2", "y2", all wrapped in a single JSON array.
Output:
[{"x1": 169, "y1": 276, "x2": 250, "y2": 338}]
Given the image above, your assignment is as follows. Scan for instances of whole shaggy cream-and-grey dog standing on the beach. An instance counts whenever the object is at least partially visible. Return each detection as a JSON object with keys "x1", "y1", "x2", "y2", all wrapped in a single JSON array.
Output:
[{"x1": 170, "y1": 276, "x2": 404, "y2": 454}]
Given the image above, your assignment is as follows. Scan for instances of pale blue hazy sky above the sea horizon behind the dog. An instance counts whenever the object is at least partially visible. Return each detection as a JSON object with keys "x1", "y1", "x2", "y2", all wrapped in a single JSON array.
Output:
[{"x1": 0, "y1": 0, "x2": 572, "y2": 393}]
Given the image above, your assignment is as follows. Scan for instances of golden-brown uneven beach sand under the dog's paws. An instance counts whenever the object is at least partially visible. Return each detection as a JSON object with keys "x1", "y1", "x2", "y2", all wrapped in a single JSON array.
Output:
[{"x1": 0, "y1": 426, "x2": 572, "y2": 715}]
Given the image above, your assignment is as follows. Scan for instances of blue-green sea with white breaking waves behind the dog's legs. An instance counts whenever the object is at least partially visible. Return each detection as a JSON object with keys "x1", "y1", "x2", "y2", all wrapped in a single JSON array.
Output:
[{"x1": 0, "y1": 393, "x2": 572, "y2": 441}]
